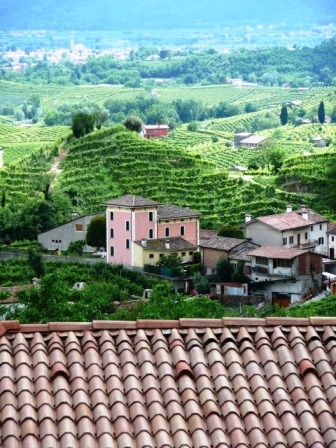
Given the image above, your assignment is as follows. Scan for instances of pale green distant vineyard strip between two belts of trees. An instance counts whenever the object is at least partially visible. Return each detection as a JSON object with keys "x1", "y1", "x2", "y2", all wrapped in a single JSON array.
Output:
[{"x1": 0, "y1": 81, "x2": 335, "y2": 111}]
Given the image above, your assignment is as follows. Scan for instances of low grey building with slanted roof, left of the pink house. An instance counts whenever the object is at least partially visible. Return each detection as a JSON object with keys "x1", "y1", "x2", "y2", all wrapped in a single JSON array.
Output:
[{"x1": 37, "y1": 213, "x2": 102, "y2": 252}]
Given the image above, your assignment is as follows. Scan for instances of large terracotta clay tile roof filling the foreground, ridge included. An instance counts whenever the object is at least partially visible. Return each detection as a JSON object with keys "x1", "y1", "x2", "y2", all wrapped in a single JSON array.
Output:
[{"x1": 0, "y1": 318, "x2": 336, "y2": 448}]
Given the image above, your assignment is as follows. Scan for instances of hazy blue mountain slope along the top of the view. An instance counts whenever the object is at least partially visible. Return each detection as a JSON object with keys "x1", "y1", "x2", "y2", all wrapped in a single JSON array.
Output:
[{"x1": 0, "y1": 0, "x2": 336, "y2": 30}]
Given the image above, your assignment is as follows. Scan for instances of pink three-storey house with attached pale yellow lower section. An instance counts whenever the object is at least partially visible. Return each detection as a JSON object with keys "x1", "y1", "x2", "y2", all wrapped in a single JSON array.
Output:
[{"x1": 105, "y1": 195, "x2": 200, "y2": 269}]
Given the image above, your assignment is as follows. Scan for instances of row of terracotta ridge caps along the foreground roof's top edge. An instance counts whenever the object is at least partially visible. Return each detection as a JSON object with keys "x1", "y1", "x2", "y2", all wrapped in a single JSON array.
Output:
[{"x1": 0, "y1": 316, "x2": 336, "y2": 337}]
